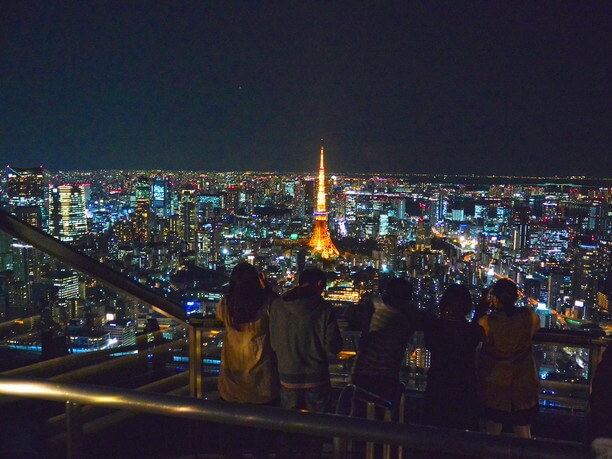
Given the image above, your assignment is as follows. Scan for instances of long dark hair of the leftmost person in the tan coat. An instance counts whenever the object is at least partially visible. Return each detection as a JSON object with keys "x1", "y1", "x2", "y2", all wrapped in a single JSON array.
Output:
[{"x1": 227, "y1": 263, "x2": 266, "y2": 330}]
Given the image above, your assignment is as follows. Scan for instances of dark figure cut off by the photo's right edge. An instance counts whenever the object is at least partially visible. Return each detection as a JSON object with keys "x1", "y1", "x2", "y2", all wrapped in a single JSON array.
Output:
[{"x1": 588, "y1": 346, "x2": 612, "y2": 459}]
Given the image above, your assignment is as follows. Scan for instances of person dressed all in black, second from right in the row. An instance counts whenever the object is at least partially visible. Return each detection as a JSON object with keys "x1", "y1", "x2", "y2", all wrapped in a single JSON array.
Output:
[{"x1": 419, "y1": 284, "x2": 482, "y2": 430}]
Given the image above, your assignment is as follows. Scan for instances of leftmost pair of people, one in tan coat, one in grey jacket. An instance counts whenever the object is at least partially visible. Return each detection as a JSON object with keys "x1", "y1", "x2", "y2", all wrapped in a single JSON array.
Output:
[{"x1": 217, "y1": 263, "x2": 342, "y2": 458}]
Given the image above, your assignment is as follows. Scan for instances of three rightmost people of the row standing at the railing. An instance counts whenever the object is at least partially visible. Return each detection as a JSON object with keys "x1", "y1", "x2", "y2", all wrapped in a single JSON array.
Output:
[{"x1": 353, "y1": 278, "x2": 540, "y2": 438}]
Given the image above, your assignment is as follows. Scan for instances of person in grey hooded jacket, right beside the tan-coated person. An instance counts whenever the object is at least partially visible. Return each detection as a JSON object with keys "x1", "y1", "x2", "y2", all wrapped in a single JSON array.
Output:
[{"x1": 270, "y1": 268, "x2": 342, "y2": 458}]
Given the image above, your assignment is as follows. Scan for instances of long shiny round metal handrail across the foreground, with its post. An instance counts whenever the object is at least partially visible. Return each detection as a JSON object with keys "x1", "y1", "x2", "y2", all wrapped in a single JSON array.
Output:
[{"x1": 0, "y1": 376, "x2": 589, "y2": 459}]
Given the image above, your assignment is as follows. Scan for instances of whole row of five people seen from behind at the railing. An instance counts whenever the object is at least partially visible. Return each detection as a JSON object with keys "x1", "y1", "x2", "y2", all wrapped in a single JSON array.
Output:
[{"x1": 217, "y1": 263, "x2": 539, "y2": 458}]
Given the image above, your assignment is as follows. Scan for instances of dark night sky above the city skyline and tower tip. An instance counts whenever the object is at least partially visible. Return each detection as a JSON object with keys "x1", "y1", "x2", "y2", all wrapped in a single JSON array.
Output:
[{"x1": 0, "y1": 0, "x2": 612, "y2": 177}]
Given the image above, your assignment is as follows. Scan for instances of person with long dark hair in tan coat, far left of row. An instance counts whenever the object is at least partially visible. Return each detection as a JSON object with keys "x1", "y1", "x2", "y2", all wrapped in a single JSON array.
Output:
[{"x1": 217, "y1": 263, "x2": 280, "y2": 457}]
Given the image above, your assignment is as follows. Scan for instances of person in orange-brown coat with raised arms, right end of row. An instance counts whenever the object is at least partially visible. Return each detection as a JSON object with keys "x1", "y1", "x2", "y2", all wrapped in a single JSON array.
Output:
[{"x1": 478, "y1": 279, "x2": 540, "y2": 438}]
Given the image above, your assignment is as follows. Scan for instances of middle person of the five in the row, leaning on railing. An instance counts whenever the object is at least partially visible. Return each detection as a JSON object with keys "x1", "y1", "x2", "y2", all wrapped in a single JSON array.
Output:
[{"x1": 353, "y1": 278, "x2": 414, "y2": 406}]
